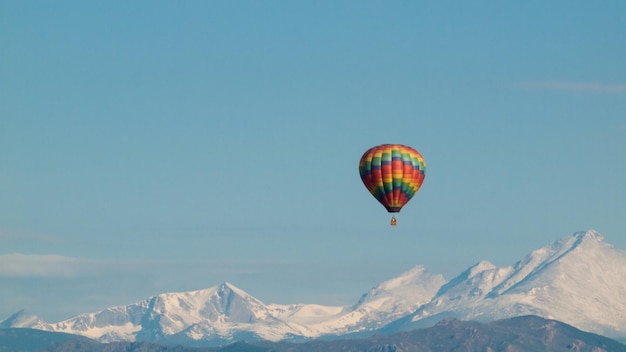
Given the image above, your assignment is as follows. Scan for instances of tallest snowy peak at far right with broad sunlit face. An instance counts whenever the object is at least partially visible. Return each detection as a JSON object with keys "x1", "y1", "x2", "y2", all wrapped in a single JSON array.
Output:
[{"x1": 492, "y1": 231, "x2": 626, "y2": 336}]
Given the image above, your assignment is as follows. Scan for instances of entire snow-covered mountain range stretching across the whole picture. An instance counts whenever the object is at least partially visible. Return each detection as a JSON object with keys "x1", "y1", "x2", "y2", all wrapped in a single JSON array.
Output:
[{"x1": 0, "y1": 231, "x2": 626, "y2": 346}]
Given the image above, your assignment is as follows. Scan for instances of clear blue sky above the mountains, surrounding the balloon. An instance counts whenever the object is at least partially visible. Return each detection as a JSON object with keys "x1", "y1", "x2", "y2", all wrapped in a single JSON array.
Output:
[{"x1": 0, "y1": 0, "x2": 626, "y2": 322}]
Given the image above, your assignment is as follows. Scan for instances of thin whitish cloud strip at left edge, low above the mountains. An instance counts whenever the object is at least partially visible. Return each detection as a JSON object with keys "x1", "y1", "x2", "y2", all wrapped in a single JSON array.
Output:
[{"x1": 0, "y1": 253, "x2": 89, "y2": 277}]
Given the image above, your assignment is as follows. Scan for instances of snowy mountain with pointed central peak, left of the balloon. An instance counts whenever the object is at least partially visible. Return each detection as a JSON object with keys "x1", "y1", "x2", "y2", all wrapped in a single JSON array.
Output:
[{"x1": 53, "y1": 282, "x2": 316, "y2": 341}]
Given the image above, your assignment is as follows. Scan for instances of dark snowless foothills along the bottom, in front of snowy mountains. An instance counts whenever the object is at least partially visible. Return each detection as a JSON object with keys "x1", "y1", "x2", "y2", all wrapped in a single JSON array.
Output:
[{"x1": 9, "y1": 316, "x2": 626, "y2": 352}]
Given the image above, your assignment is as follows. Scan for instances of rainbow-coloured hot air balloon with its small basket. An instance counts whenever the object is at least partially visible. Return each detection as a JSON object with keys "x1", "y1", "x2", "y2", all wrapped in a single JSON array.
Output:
[{"x1": 359, "y1": 144, "x2": 426, "y2": 226}]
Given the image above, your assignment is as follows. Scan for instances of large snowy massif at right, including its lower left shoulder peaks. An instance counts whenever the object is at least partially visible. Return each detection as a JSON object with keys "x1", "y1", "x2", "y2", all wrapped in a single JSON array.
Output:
[{"x1": 394, "y1": 231, "x2": 626, "y2": 338}]
